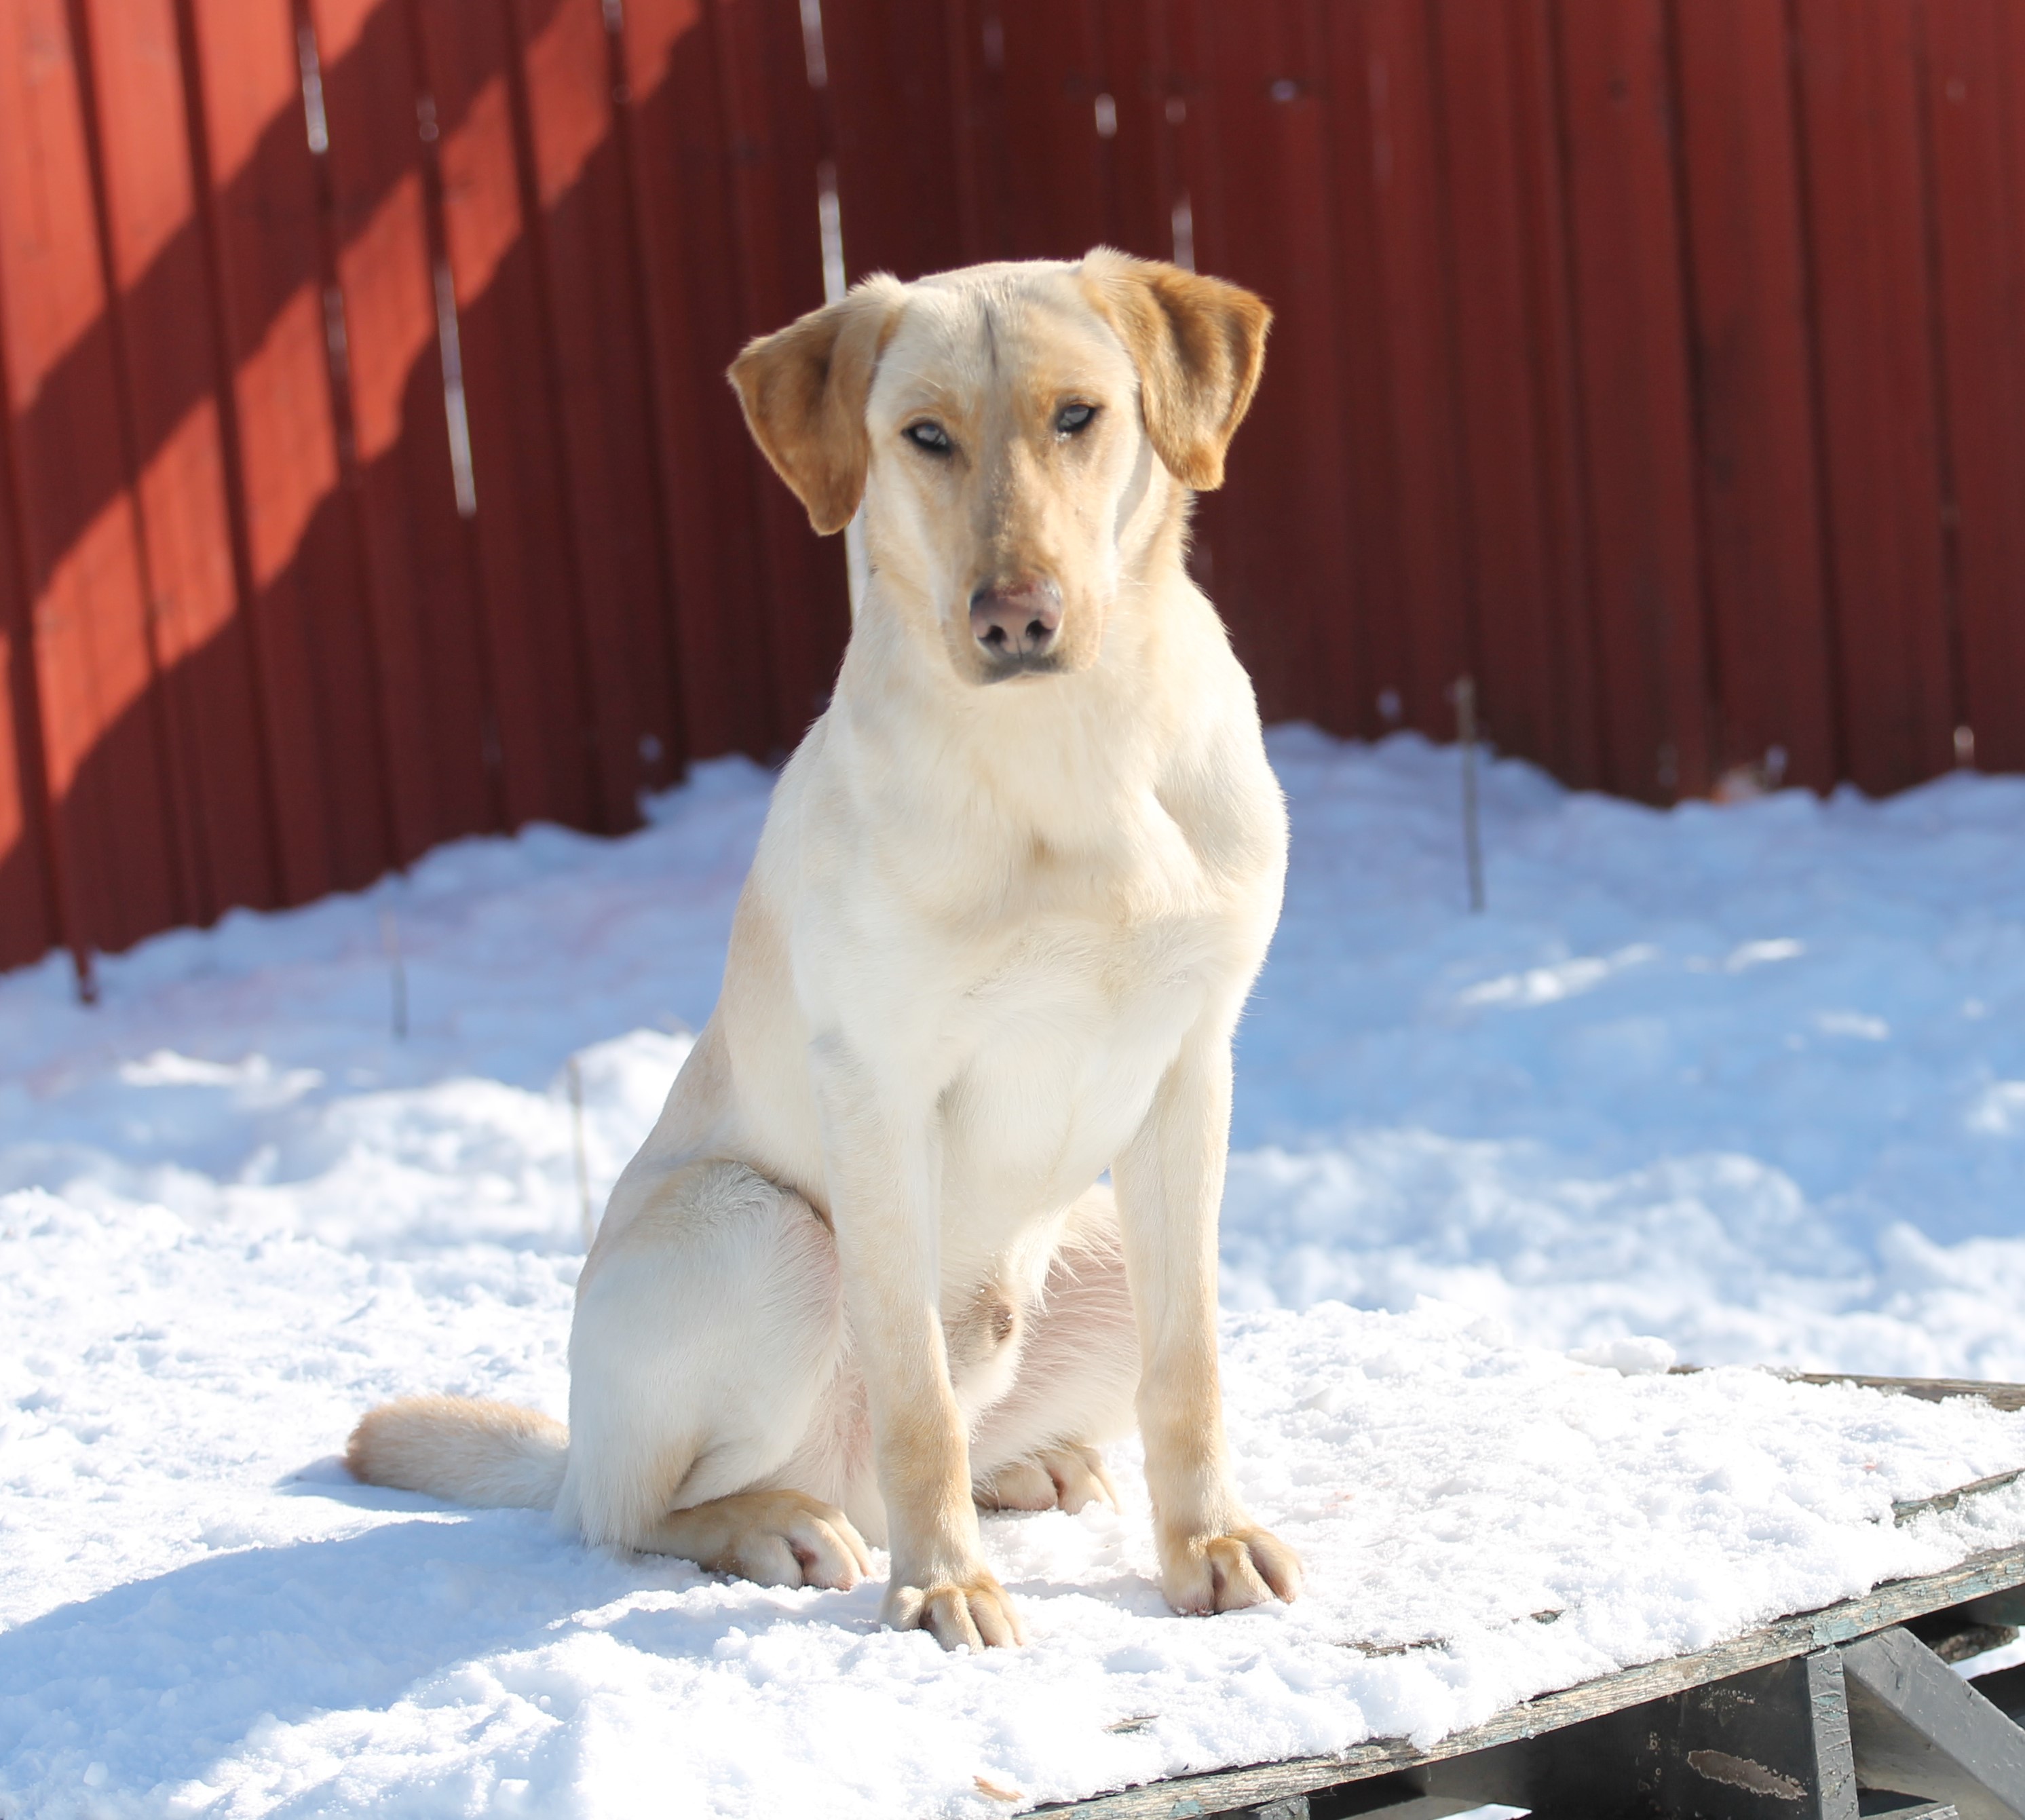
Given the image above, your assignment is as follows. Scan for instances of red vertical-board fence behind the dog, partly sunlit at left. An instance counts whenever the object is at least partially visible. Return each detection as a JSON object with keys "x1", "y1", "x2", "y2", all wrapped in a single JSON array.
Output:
[{"x1": 0, "y1": 0, "x2": 2025, "y2": 983}]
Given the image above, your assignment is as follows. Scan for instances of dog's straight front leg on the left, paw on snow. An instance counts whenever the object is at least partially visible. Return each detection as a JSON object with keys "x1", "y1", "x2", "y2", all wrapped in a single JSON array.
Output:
[{"x1": 814, "y1": 1040, "x2": 1027, "y2": 1650}]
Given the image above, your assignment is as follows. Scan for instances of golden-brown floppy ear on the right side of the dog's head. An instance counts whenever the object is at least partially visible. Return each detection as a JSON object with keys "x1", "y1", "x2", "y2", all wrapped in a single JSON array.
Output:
[{"x1": 1081, "y1": 247, "x2": 1272, "y2": 490}]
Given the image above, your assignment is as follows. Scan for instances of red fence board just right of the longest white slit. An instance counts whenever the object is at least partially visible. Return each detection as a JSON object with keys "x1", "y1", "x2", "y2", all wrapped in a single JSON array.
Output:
[{"x1": 409, "y1": 0, "x2": 599, "y2": 828}]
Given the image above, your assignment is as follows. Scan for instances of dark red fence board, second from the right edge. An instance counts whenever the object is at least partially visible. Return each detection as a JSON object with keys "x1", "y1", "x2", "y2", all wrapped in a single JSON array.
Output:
[{"x1": 1794, "y1": 0, "x2": 1954, "y2": 791}]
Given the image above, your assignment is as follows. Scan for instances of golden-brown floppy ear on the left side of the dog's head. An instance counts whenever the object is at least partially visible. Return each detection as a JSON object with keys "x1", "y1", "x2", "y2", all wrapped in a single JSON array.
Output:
[{"x1": 731, "y1": 273, "x2": 905, "y2": 537}]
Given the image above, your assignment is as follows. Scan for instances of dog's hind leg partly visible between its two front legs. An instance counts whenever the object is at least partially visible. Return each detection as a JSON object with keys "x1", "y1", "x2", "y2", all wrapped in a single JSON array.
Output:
[{"x1": 970, "y1": 1186, "x2": 1140, "y2": 1511}]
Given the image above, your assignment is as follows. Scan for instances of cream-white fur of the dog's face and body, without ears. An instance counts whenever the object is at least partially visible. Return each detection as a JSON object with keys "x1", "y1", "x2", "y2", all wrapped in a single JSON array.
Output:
[{"x1": 354, "y1": 255, "x2": 1298, "y2": 1642}]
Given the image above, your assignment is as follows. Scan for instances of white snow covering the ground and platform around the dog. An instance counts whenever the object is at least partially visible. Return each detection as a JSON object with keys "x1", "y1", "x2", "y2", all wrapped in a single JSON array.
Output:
[{"x1": 0, "y1": 729, "x2": 2025, "y2": 1820}]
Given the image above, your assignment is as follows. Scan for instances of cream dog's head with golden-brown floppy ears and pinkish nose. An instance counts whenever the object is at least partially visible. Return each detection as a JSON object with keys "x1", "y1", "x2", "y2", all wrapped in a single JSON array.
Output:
[{"x1": 731, "y1": 249, "x2": 1272, "y2": 684}]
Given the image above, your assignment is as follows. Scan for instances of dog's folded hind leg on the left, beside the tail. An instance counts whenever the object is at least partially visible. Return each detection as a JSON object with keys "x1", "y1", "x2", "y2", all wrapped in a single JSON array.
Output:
[{"x1": 557, "y1": 1162, "x2": 877, "y2": 1585}]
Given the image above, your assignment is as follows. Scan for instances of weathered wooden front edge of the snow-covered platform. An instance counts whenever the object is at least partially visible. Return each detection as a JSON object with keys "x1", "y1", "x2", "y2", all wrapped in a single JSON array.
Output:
[{"x1": 1031, "y1": 1547, "x2": 2025, "y2": 1820}]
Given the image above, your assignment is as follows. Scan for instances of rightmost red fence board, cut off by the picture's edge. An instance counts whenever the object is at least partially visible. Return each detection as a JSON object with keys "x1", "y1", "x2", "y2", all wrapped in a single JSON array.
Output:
[{"x1": 1926, "y1": 0, "x2": 2025, "y2": 772}]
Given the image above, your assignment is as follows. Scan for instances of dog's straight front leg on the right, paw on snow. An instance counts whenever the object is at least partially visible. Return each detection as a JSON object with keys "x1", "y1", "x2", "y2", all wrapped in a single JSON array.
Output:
[{"x1": 1112, "y1": 1031, "x2": 1300, "y2": 1612}]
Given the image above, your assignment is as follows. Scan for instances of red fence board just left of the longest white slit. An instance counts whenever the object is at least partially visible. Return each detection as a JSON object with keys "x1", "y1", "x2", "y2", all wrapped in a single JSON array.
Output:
[{"x1": 309, "y1": 0, "x2": 492, "y2": 860}]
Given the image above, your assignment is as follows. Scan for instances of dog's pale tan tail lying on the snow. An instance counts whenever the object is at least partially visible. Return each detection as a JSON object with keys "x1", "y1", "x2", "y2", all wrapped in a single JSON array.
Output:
[{"x1": 344, "y1": 1397, "x2": 569, "y2": 1511}]
